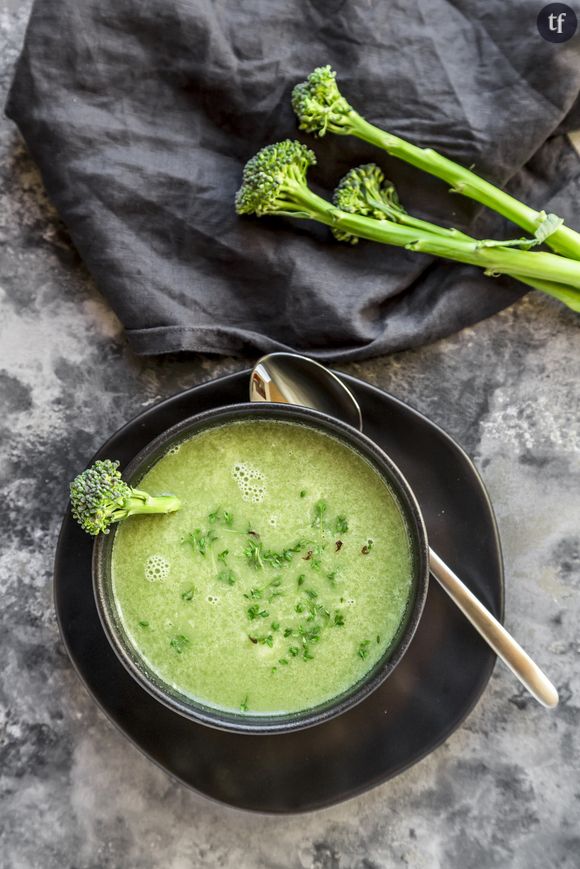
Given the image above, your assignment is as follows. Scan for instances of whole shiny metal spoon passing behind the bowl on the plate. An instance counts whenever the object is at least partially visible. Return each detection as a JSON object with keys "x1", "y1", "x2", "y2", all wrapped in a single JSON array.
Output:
[{"x1": 250, "y1": 353, "x2": 558, "y2": 708}]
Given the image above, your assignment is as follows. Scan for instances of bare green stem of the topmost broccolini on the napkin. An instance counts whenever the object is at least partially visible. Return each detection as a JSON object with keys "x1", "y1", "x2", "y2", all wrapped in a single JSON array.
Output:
[{"x1": 345, "y1": 109, "x2": 580, "y2": 260}]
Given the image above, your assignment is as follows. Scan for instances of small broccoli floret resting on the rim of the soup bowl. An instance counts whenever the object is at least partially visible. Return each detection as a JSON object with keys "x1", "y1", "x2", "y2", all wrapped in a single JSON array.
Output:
[{"x1": 70, "y1": 459, "x2": 181, "y2": 536}]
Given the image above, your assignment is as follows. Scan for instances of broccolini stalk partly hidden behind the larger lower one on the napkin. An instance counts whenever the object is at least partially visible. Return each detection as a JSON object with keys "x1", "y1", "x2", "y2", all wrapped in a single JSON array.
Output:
[{"x1": 333, "y1": 163, "x2": 580, "y2": 310}]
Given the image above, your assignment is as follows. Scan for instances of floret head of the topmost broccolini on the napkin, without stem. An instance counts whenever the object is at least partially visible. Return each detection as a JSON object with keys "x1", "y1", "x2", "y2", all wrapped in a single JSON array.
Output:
[{"x1": 292, "y1": 66, "x2": 356, "y2": 136}]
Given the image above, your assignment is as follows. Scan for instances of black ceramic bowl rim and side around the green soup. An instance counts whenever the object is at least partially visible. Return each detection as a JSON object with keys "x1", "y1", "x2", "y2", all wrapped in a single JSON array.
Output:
[{"x1": 93, "y1": 404, "x2": 429, "y2": 734}]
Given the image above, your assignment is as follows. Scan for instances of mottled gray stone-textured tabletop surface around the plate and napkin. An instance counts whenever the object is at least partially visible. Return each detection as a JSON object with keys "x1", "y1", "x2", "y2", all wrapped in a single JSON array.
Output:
[{"x1": 0, "y1": 0, "x2": 580, "y2": 869}]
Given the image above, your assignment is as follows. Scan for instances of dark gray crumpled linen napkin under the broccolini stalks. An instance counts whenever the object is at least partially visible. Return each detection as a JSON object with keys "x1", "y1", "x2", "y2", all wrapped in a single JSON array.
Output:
[{"x1": 7, "y1": 0, "x2": 580, "y2": 360}]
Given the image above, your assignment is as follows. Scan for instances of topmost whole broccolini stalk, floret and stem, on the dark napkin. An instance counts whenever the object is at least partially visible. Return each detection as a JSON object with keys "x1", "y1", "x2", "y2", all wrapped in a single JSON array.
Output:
[{"x1": 292, "y1": 66, "x2": 580, "y2": 259}]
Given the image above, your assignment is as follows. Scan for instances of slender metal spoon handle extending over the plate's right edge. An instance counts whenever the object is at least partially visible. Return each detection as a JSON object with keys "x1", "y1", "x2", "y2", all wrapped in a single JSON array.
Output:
[{"x1": 429, "y1": 549, "x2": 558, "y2": 708}]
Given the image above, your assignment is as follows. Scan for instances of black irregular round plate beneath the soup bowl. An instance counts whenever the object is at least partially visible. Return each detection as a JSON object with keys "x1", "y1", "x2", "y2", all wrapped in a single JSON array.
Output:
[{"x1": 54, "y1": 371, "x2": 503, "y2": 812}]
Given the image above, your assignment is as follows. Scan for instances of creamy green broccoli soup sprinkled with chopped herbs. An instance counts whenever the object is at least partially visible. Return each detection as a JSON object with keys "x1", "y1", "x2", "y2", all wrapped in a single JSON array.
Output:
[{"x1": 112, "y1": 420, "x2": 412, "y2": 714}]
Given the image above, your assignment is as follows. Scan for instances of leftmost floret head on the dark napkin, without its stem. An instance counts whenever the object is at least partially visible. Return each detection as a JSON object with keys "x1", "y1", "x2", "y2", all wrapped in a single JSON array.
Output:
[{"x1": 236, "y1": 139, "x2": 328, "y2": 217}]
